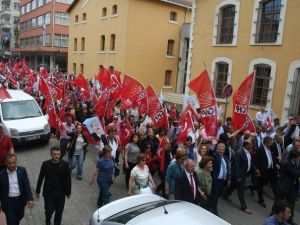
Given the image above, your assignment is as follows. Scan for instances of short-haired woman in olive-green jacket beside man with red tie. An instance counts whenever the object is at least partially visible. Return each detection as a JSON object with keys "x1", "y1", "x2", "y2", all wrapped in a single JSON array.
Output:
[{"x1": 196, "y1": 156, "x2": 213, "y2": 210}]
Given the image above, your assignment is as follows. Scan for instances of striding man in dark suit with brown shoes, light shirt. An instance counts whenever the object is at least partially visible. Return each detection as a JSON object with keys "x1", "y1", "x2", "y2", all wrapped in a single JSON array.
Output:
[{"x1": 224, "y1": 140, "x2": 255, "y2": 214}]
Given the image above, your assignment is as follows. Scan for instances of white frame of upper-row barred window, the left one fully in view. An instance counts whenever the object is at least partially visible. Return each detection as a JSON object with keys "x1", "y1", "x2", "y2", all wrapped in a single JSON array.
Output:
[{"x1": 212, "y1": 0, "x2": 240, "y2": 46}]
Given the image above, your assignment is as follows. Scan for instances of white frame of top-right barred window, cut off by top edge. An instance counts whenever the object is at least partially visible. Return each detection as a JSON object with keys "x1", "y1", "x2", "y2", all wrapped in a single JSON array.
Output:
[{"x1": 250, "y1": 0, "x2": 287, "y2": 45}]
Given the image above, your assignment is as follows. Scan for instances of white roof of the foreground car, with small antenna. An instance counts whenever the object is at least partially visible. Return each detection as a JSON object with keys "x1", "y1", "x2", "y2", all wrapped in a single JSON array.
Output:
[{"x1": 127, "y1": 201, "x2": 230, "y2": 225}]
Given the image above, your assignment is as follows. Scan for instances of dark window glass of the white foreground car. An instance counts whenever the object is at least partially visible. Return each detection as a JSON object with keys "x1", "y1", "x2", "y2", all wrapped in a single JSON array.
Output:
[{"x1": 105, "y1": 200, "x2": 178, "y2": 224}]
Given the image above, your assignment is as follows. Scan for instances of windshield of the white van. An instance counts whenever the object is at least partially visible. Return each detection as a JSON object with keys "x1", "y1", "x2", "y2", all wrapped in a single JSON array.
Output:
[{"x1": 1, "y1": 100, "x2": 43, "y2": 120}]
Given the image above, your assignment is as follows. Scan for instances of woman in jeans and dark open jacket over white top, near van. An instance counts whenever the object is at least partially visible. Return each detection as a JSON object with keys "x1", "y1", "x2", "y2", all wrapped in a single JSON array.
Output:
[{"x1": 68, "y1": 124, "x2": 87, "y2": 180}]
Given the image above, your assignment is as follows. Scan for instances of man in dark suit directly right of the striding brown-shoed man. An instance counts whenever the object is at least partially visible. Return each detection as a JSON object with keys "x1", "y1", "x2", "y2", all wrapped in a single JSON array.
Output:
[{"x1": 254, "y1": 136, "x2": 277, "y2": 208}]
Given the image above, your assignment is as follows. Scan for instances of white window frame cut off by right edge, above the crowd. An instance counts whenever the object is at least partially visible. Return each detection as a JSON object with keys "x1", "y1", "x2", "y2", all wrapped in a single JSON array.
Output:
[{"x1": 281, "y1": 59, "x2": 300, "y2": 121}]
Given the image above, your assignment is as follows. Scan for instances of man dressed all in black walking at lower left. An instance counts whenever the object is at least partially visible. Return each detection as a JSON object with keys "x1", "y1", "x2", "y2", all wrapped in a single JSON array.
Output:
[{"x1": 35, "y1": 146, "x2": 71, "y2": 225}]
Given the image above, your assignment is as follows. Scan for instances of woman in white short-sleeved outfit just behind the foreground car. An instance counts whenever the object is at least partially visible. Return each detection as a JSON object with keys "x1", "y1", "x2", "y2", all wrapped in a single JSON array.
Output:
[{"x1": 128, "y1": 154, "x2": 156, "y2": 195}]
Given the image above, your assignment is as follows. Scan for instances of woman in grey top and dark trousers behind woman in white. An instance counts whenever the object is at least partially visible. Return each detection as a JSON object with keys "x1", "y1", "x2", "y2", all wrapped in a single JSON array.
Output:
[{"x1": 124, "y1": 134, "x2": 141, "y2": 190}]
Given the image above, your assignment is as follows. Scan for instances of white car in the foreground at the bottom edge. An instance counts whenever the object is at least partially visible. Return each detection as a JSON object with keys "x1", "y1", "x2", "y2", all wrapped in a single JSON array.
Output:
[{"x1": 89, "y1": 194, "x2": 230, "y2": 225}]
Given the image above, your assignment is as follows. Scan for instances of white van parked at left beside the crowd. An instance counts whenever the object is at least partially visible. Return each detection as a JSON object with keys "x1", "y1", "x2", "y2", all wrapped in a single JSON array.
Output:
[{"x1": 0, "y1": 90, "x2": 50, "y2": 145}]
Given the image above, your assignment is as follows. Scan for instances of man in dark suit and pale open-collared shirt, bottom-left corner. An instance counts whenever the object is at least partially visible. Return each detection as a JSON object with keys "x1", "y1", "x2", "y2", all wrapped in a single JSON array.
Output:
[{"x1": 0, "y1": 154, "x2": 34, "y2": 225}]
